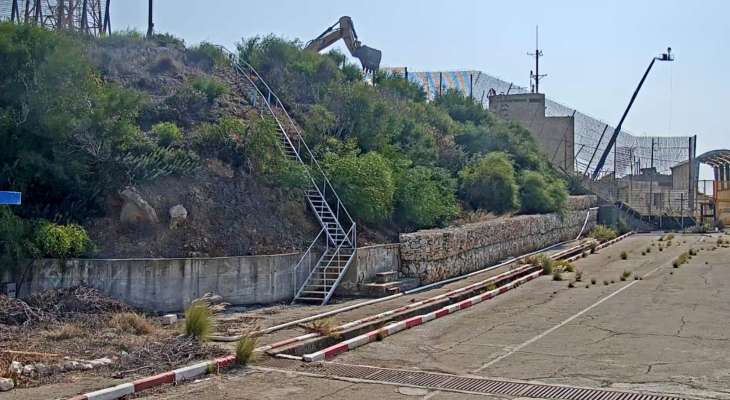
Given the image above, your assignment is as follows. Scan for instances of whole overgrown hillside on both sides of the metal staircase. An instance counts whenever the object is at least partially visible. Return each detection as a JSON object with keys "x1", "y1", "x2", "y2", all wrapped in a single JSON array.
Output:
[{"x1": 0, "y1": 24, "x2": 567, "y2": 260}]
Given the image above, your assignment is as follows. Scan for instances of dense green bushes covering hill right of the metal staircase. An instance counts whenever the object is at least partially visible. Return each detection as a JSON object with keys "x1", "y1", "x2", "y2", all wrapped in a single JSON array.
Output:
[{"x1": 238, "y1": 36, "x2": 567, "y2": 230}]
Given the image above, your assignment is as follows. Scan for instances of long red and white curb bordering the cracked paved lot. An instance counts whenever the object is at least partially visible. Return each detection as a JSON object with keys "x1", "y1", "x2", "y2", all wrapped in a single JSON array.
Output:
[{"x1": 302, "y1": 270, "x2": 542, "y2": 362}]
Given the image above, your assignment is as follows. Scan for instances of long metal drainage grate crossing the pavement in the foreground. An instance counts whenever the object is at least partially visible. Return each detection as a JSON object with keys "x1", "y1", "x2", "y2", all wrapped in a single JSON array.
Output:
[{"x1": 258, "y1": 358, "x2": 684, "y2": 400}]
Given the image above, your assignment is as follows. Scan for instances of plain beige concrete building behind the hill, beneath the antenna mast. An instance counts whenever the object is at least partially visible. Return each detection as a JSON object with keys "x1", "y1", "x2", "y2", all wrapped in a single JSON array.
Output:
[{"x1": 489, "y1": 93, "x2": 575, "y2": 174}]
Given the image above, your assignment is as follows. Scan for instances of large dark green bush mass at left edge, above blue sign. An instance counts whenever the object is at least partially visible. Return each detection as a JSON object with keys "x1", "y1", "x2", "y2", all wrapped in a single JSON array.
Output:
[{"x1": 0, "y1": 23, "x2": 144, "y2": 220}]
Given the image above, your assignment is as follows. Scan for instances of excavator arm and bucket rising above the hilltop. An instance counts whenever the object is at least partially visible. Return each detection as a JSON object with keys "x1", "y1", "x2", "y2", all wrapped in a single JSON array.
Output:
[{"x1": 304, "y1": 16, "x2": 383, "y2": 73}]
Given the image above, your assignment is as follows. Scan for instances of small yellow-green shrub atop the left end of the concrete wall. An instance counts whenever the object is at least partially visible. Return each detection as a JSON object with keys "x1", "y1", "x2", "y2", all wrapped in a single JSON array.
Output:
[{"x1": 35, "y1": 222, "x2": 91, "y2": 258}]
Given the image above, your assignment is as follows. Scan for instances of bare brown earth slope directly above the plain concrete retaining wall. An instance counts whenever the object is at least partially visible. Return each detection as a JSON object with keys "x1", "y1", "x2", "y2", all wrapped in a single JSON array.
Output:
[{"x1": 87, "y1": 161, "x2": 319, "y2": 258}]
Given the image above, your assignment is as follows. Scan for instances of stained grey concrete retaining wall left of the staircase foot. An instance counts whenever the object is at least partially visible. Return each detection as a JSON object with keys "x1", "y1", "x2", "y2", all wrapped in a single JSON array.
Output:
[{"x1": 18, "y1": 253, "x2": 307, "y2": 312}]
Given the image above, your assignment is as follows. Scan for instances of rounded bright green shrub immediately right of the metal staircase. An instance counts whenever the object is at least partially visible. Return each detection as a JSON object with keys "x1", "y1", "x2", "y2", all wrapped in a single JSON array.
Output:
[{"x1": 325, "y1": 152, "x2": 395, "y2": 223}]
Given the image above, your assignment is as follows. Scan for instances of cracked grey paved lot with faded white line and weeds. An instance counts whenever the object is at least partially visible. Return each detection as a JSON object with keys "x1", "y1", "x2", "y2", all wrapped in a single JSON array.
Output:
[{"x1": 138, "y1": 235, "x2": 730, "y2": 400}]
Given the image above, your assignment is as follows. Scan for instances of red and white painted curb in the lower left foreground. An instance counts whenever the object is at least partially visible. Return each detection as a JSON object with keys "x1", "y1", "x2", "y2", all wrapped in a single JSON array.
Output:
[{"x1": 69, "y1": 355, "x2": 236, "y2": 400}]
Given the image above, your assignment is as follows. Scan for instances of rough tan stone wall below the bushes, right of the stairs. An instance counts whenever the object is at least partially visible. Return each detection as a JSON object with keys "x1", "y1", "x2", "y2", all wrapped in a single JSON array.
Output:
[{"x1": 400, "y1": 208, "x2": 597, "y2": 284}]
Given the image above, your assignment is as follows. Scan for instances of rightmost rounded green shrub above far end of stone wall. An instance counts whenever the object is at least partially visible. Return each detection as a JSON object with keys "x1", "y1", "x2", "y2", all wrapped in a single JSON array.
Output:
[{"x1": 520, "y1": 171, "x2": 568, "y2": 214}]
